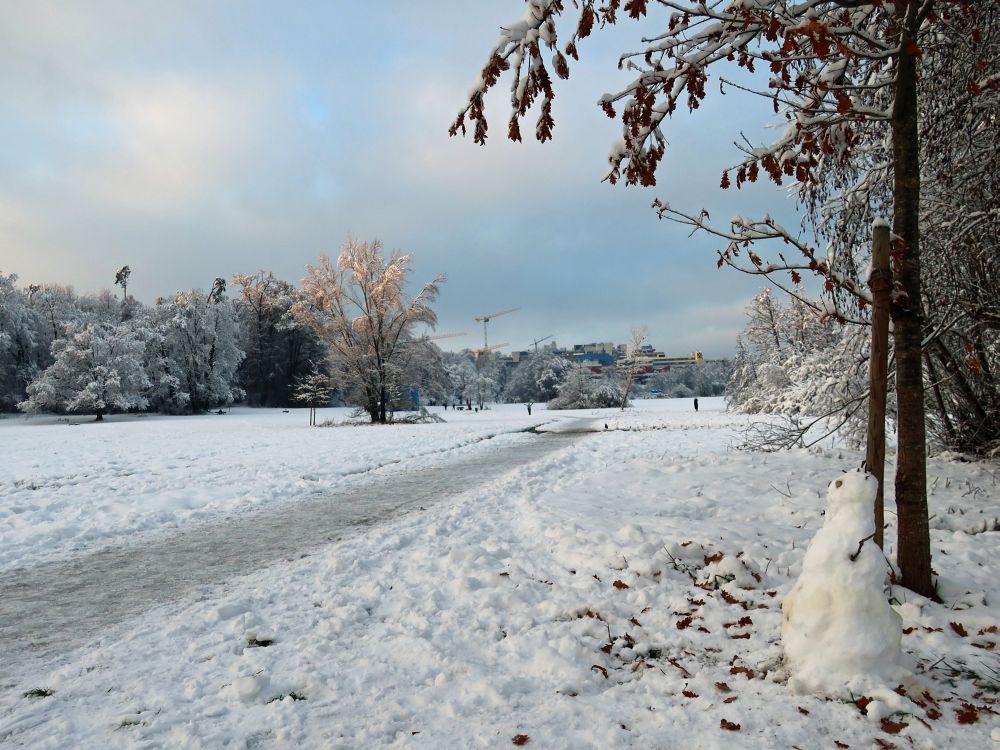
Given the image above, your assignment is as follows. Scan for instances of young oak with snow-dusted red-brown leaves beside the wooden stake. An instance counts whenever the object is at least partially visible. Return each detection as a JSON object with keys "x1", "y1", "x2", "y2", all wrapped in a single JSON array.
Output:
[{"x1": 451, "y1": 0, "x2": 997, "y2": 595}]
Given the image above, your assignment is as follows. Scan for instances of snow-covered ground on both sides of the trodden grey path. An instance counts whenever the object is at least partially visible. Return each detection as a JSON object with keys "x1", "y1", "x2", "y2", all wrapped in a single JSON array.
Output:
[{"x1": 0, "y1": 399, "x2": 1000, "y2": 750}]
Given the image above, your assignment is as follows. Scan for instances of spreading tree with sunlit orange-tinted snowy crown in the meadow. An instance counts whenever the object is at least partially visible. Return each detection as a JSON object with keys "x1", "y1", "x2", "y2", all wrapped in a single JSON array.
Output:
[{"x1": 294, "y1": 238, "x2": 444, "y2": 424}]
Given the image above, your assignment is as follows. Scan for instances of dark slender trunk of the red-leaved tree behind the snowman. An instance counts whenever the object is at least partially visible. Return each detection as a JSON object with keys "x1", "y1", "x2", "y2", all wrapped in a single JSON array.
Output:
[{"x1": 891, "y1": 17, "x2": 935, "y2": 597}]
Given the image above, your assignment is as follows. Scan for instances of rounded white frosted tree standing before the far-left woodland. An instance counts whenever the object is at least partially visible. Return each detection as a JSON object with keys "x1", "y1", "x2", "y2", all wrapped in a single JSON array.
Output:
[{"x1": 18, "y1": 323, "x2": 149, "y2": 422}]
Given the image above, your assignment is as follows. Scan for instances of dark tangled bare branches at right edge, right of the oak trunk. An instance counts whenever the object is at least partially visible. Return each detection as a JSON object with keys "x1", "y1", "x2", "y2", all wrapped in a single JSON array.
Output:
[{"x1": 920, "y1": 7, "x2": 1000, "y2": 454}]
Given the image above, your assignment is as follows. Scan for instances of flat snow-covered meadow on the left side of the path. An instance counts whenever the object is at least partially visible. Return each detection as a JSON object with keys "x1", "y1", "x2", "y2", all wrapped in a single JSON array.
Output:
[{"x1": 0, "y1": 407, "x2": 551, "y2": 570}]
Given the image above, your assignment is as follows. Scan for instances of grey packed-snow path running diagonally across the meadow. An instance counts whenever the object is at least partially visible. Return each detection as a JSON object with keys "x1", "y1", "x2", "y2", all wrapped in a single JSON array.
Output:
[{"x1": 0, "y1": 436, "x2": 572, "y2": 687}]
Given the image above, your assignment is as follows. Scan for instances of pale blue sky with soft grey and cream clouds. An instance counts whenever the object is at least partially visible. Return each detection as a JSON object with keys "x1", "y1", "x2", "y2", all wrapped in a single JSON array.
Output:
[{"x1": 0, "y1": 0, "x2": 794, "y2": 356}]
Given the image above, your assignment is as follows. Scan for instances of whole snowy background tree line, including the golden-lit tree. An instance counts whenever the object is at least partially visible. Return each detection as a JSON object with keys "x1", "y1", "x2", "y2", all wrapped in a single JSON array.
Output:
[{"x1": 0, "y1": 248, "x2": 728, "y2": 423}]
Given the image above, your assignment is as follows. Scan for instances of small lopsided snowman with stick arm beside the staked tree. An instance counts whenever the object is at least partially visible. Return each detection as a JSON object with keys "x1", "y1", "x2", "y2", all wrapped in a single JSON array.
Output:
[{"x1": 781, "y1": 470, "x2": 908, "y2": 698}]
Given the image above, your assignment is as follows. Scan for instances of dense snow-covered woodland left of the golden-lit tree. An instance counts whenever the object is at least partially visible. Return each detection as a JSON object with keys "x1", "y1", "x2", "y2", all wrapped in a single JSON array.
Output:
[{"x1": 0, "y1": 266, "x2": 326, "y2": 419}]
